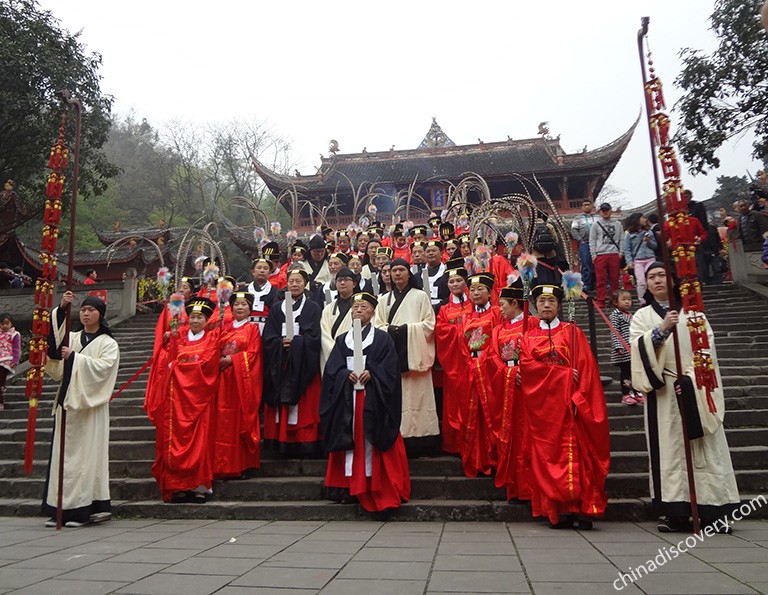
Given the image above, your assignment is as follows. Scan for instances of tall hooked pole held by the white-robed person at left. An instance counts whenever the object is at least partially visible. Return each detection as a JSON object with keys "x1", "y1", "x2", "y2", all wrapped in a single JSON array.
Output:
[{"x1": 53, "y1": 91, "x2": 83, "y2": 530}]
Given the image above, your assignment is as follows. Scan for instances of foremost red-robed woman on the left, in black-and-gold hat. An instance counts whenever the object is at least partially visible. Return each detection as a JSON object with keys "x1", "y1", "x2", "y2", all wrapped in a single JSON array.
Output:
[{"x1": 152, "y1": 298, "x2": 220, "y2": 504}]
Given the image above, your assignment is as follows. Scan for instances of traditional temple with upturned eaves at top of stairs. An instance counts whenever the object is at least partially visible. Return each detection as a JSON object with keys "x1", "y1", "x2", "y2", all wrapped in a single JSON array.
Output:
[{"x1": 255, "y1": 118, "x2": 637, "y2": 232}]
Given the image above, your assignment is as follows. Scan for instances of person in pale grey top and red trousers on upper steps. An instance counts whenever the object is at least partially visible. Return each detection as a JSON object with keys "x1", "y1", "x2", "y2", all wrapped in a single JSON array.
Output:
[{"x1": 589, "y1": 202, "x2": 624, "y2": 307}]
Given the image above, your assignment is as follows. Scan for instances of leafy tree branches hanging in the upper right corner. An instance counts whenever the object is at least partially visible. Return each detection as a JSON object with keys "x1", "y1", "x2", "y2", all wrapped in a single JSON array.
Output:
[{"x1": 675, "y1": 0, "x2": 768, "y2": 173}]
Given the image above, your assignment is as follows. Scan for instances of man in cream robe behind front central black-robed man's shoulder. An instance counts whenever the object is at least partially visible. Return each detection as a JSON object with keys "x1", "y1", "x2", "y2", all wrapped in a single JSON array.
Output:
[{"x1": 374, "y1": 258, "x2": 440, "y2": 438}]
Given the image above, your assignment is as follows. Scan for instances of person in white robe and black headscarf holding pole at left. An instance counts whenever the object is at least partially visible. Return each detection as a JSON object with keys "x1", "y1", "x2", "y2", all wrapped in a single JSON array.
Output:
[{"x1": 42, "y1": 291, "x2": 120, "y2": 527}]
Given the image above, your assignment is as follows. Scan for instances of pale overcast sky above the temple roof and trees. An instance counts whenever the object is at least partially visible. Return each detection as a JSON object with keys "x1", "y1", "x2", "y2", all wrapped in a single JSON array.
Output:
[{"x1": 41, "y1": 0, "x2": 759, "y2": 206}]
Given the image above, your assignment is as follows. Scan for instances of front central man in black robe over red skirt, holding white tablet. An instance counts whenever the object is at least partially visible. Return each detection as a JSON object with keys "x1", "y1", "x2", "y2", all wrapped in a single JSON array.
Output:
[{"x1": 320, "y1": 292, "x2": 411, "y2": 518}]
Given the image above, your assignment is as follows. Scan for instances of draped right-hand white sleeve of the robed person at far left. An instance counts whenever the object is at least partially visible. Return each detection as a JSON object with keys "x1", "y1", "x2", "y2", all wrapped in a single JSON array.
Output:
[{"x1": 64, "y1": 334, "x2": 120, "y2": 410}]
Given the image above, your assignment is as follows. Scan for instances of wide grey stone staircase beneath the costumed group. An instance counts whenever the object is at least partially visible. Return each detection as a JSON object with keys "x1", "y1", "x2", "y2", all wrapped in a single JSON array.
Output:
[{"x1": 0, "y1": 285, "x2": 768, "y2": 521}]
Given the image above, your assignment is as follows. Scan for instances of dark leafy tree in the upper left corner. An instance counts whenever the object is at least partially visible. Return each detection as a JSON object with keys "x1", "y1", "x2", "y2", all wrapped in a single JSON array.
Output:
[{"x1": 0, "y1": 0, "x2": 116, "y2": 217}]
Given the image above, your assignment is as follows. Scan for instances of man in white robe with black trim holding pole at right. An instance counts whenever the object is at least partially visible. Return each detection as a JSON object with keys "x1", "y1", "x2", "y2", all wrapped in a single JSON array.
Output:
[{"x1": 630, "y1": 262, "x2": 739, "y2": 532}]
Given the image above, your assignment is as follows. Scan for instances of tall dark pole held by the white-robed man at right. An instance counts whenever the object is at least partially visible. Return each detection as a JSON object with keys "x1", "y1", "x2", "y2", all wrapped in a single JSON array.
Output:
[{"x1": 637, "y1": 17, "x2": 700, "y2": 533}]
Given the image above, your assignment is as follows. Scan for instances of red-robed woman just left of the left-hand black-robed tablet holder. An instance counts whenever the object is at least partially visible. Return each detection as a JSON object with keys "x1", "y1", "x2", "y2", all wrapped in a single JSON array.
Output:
[{"x1": 211, "y1": 291, "x2": 262, "y2": 479}]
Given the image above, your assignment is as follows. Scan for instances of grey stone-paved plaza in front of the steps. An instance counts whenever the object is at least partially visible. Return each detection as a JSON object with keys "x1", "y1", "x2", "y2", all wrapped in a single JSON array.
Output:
[{"x1": 0, "y1": 517, "x2": 768, "y2": 595}]
